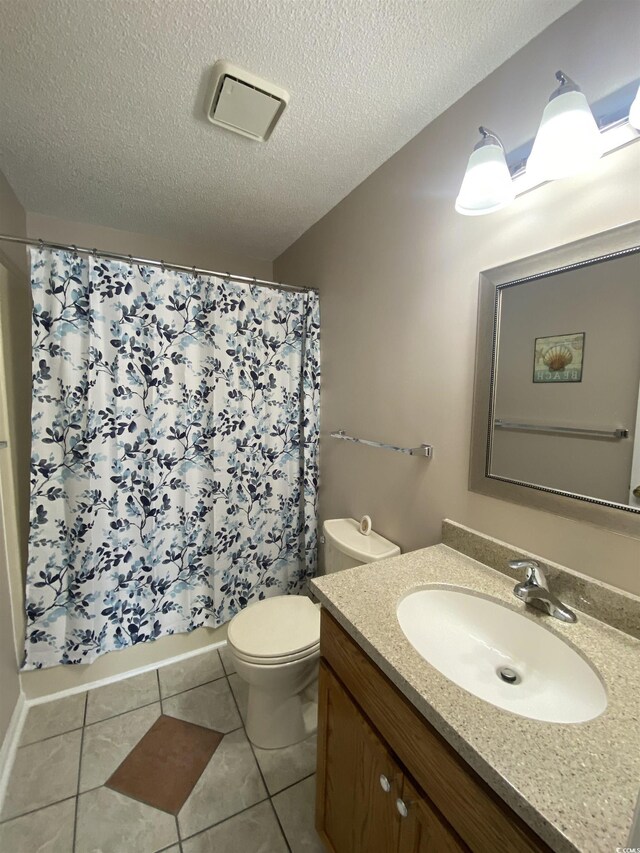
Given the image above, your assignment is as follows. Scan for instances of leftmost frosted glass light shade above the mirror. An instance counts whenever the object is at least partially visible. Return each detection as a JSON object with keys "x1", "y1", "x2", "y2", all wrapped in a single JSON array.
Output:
[{"x1": 456, "y1": 143, "x2": 515, "y2": 216}]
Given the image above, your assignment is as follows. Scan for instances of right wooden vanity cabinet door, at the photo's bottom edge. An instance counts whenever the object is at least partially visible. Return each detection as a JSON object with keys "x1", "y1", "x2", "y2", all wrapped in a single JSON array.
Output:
[{"x1": 398, "y1": 776, "x2": 469, "y2": 853}]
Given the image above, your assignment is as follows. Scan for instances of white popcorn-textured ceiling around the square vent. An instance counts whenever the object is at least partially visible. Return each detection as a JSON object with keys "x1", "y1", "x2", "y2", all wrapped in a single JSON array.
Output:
[{"x1": 0, "y1": 0, "x2": 577, "y2": 259}]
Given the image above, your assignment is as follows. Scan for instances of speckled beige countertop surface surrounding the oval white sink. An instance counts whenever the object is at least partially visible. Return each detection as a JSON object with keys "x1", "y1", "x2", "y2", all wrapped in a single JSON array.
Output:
[{"x1": 311, "y1": 545, "x2": 640, "y2": 853}]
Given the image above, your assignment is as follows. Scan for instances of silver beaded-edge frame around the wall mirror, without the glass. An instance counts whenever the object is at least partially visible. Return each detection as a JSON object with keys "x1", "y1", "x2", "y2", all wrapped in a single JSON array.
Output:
[{"x1": 469, "y1": 221, "x2": 640, "y2": 538}]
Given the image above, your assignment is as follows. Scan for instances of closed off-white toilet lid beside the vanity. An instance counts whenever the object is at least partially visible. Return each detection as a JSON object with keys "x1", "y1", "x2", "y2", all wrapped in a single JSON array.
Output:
[{"x1": 228, "y1": 595, "x2": 320, "y2": 659}]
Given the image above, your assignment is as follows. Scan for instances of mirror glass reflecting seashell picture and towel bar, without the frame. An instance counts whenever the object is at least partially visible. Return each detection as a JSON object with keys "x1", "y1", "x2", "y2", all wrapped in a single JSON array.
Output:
[{"x1": 487, "y1": 249, "x2": 640, "y2": 511}]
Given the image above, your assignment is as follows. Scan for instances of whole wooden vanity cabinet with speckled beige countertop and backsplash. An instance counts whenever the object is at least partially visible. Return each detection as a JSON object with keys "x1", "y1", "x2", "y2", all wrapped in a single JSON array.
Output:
[{"x1": 312, "y1": 522, "x2": 640, "y2": 853}]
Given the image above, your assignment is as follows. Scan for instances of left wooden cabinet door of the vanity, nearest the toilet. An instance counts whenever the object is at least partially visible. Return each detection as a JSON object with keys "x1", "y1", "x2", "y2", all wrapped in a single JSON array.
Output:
[{"x1": 316, "y1": 662, "x2": 402, "y2": 853}]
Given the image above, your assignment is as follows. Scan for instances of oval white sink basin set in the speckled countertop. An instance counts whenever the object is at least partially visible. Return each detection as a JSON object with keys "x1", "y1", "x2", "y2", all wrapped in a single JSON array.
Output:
[{"x1": 397, "y1": 587, "x2": 607, "y2": 723}]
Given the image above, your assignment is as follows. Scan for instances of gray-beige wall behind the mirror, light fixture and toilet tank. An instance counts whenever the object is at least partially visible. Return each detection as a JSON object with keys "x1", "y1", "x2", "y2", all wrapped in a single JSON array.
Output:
[{"x1": 275, "y1": 0, "x2": 640, "y2": 593}]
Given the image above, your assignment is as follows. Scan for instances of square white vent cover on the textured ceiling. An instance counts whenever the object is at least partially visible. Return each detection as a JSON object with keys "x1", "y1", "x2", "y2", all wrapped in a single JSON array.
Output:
[{"x1": 207, "y1": 60, "x2": 289, "y2": 142}]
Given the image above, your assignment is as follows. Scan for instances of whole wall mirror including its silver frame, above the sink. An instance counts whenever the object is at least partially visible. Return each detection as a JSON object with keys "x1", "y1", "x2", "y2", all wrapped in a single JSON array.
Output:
[{"x1": 469, "y1": 222, "x2": 640, "y2": 536}]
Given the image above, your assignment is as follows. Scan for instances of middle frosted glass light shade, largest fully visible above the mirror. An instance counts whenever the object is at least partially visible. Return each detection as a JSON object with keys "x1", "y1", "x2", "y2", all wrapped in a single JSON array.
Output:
[{"x1": 527, "y1": 91, "x2": 603, "y2": 181}]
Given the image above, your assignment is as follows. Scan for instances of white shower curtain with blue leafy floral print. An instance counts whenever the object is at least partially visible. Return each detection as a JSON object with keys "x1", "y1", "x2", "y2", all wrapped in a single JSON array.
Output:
[{"x1": 23, "y1": 248, "x2": 319, "y2": 669}]
